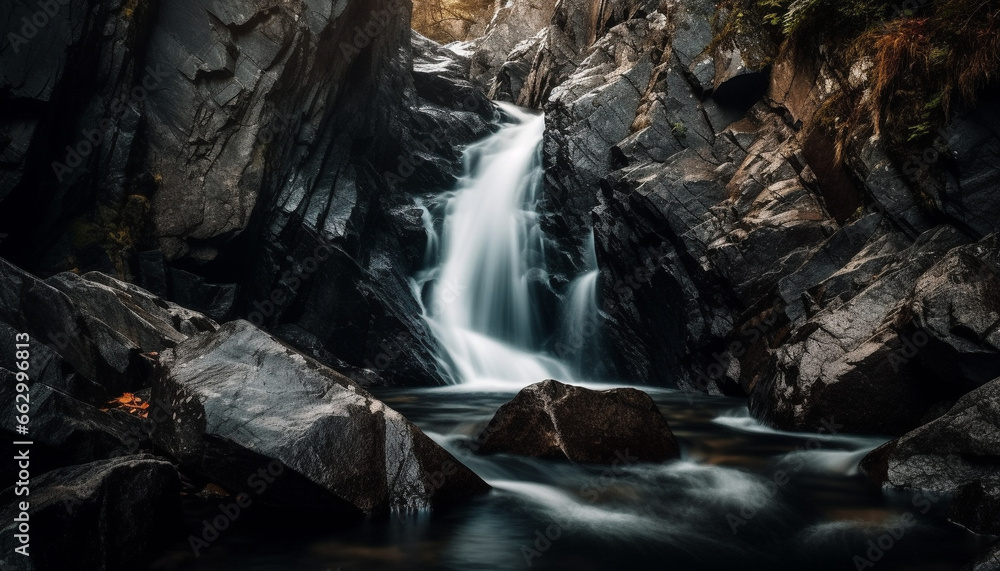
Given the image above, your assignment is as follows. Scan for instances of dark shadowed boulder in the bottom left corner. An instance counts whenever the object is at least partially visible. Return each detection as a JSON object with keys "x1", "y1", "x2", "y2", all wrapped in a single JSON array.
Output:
[{"x1": 0, "y1": 456, "x2": 181, "y2": 571}]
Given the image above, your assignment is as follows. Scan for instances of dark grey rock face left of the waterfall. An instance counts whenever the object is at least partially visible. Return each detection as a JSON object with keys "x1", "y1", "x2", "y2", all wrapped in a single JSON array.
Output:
[{"x1": 0, "y1": 0, "x2": 496, "y2": 384}]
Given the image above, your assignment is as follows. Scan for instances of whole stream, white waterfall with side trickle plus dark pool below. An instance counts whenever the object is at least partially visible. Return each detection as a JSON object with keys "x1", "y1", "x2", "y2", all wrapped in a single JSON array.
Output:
[{"x1": 154, "y1": 106, "x2": 979, "y2": 571}]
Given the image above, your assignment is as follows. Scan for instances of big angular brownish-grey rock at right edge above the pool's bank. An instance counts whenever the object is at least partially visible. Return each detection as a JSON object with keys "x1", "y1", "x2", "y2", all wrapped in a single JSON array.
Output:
[{"x1": 752, "y1": 228, "x2": 1000, "y2": 434}]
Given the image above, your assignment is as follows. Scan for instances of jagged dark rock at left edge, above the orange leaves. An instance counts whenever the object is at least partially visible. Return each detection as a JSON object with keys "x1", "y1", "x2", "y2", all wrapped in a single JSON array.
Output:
[{"x1": 0, "y1": 259, "x2": 217, "y2": 404}]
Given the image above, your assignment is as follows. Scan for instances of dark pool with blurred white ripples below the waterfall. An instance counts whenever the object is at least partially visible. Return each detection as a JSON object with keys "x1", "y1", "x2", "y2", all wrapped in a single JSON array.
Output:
[{"x1": 153, "y1": 389, "x2": 985, "y2": 571}]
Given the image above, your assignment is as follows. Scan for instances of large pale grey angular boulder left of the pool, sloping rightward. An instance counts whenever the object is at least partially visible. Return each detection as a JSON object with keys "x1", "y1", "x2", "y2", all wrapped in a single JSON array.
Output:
[{"x1": 152, "y1": 321, "x2": 489, "y2": 514}]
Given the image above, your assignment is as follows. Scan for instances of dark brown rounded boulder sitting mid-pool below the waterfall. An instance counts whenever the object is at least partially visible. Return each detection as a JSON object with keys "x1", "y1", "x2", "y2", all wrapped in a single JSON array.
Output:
[{"x1": 479, "y1": 380, "x2": 680, "y2": 464}]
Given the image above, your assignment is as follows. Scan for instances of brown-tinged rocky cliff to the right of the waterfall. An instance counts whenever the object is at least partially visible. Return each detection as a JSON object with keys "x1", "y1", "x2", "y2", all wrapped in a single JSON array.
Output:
[{"x1": 472, "y1": 0, "x2": 1000, "y2": 440}]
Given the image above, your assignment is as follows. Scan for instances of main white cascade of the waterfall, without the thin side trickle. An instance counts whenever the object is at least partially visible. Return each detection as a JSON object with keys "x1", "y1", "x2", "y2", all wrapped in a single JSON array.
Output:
[{"x1": 413, "y1": 103, "x2": 573, "y2": 387}]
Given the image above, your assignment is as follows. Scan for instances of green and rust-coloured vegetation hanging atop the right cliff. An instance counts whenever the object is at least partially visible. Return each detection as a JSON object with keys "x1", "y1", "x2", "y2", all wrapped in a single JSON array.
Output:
[{"x1": 748, "y1": 0, "x2": 1000, "y2": 146}]
